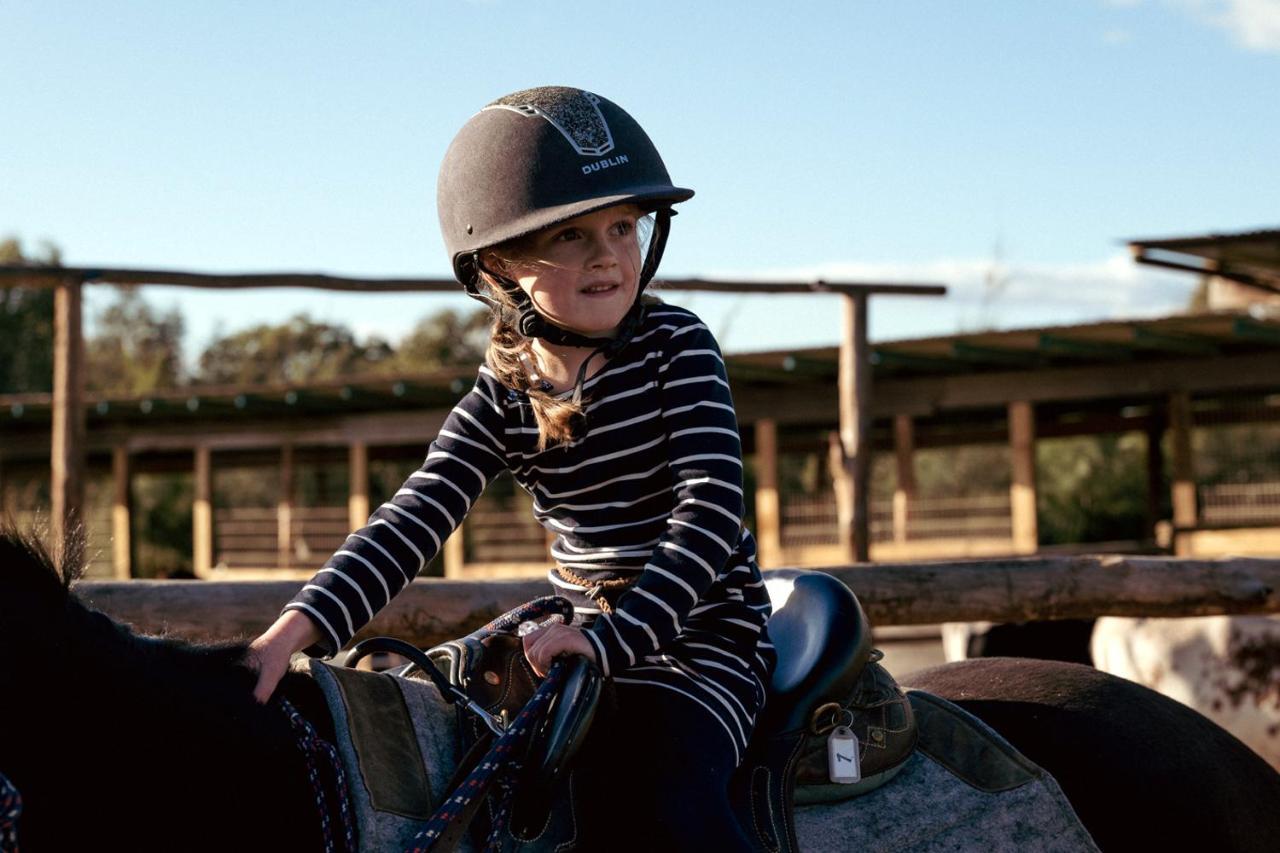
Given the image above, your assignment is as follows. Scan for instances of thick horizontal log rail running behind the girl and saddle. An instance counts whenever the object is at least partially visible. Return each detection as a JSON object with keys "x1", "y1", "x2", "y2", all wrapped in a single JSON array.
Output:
[{"x1": 77, "y1": 556, "x2": 1280, "y2": 646}]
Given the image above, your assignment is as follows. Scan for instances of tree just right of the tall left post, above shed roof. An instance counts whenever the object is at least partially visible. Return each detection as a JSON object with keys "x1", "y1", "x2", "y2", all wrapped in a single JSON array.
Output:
[{"x1": 84, "y1": 287, "x2": 183, "y2": 394}]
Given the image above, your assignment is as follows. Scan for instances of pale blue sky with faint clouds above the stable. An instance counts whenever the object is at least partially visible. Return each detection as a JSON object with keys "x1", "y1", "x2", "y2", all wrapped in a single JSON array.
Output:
[{"x1": 0, "y1": 0, "x2": 1280, "y2": 353}]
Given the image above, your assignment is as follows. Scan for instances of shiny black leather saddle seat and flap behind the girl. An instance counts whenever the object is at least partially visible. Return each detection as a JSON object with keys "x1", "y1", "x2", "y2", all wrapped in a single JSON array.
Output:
[{"x1": 733, "y1": 569, "x2": 872, "y2": 853}]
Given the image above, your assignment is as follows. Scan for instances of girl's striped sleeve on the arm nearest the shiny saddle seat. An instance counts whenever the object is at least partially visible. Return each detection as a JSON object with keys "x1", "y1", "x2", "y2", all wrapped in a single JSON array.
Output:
[{"x1": 588, "y1": 313, "x2": 744, "y2": 674}]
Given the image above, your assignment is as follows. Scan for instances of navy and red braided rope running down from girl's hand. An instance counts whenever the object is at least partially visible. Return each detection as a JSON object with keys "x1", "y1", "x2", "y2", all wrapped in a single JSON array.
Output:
[{"x1": 406, "y1": 662, "x2": 567, "y2": 853}]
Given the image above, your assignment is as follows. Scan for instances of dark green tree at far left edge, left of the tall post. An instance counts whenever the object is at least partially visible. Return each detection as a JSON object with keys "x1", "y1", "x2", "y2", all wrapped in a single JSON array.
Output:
[{"x1": 0, "y1": 237, "x2": 61, "y2": 393}]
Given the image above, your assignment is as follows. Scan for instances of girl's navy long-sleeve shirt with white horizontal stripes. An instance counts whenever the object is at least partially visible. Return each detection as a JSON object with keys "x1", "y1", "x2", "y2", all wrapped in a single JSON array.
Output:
[{"x1": 287, "y1": 305, "x2": 773, "y2": 742}]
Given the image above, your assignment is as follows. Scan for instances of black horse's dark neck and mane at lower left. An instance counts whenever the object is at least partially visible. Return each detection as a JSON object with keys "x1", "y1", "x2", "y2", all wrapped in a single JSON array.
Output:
[{"x1": 0, "y1": 581, "x2": 325, "y2": 849}]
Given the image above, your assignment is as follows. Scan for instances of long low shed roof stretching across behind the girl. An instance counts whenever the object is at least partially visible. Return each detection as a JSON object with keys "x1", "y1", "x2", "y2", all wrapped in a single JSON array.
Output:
[{"x1": 0, "y1": 311, "x2": 1280, "y2": 429}]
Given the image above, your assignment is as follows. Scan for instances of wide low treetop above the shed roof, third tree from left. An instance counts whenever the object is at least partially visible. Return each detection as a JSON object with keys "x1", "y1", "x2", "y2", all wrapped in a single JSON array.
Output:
[{"x1": 196, "y1": 314, "x2": 394, "y2": 384}]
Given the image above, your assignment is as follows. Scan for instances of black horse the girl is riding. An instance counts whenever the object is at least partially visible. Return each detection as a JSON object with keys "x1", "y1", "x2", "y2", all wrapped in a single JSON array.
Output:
[{"x1": 0, "y1": 533, "x2": 1280, "y2": 853}]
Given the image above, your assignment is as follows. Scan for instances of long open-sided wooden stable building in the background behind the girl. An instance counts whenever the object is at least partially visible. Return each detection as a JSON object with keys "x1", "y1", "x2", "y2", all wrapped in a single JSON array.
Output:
[{"x1": 0, "y1": 232, "x2": 1280, "y2": 578}]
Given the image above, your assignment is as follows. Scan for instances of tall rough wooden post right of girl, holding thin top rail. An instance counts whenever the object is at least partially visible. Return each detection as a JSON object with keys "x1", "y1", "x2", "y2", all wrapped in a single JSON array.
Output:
[{"x1": 836, "y1": 293, "x2": 872, "y2": 562}]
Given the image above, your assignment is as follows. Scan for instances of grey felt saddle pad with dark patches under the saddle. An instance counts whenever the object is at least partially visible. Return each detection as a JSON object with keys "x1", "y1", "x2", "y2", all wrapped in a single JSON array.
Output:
[{"x1": 306, "y1": 660, "x2": 1098, "y2": 853}]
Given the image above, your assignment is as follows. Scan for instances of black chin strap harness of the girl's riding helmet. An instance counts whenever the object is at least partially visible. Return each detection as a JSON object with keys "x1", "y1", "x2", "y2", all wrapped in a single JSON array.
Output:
[{"x1": 466, "y1": 207, "x2": 676, "y2": 400}]
